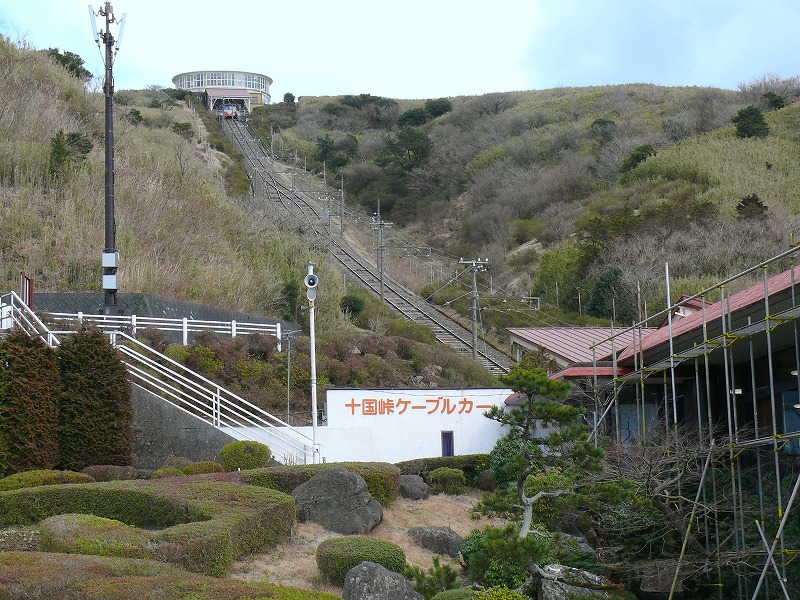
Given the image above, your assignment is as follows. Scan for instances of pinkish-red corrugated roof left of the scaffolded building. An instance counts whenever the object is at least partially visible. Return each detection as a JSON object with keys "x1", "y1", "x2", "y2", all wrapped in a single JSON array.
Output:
[{"x1": 508, "y1": 327, "x2": 653, "y2": 363}]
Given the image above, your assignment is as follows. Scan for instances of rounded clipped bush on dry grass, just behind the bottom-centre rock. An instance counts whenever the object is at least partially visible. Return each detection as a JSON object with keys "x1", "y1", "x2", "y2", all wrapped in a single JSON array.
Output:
[{"x1": 317, "y1": 535, "x2": 406, "y2": 585}]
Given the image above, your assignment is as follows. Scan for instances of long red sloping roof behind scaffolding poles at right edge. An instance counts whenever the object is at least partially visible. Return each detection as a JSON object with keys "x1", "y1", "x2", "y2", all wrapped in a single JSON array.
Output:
[{"x1": 619, "y1": 265, "x2": 800, "y2": 360}]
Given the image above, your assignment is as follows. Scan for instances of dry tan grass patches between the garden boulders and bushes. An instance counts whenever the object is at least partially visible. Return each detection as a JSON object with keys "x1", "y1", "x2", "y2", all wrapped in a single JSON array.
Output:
[{"x1": 230, "y1": 492, "x2": 505, "y2": 594}]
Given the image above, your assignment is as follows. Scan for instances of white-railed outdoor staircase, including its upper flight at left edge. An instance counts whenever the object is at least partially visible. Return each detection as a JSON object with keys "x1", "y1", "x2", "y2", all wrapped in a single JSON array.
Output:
[{"x1": 0, "y1": 292, "x2": 319, "y2": 464}]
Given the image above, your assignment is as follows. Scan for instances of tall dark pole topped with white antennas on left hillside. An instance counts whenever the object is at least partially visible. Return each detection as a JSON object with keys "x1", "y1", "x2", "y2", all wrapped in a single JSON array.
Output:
[{"x1": 89, "y1": 2, "x2": 126, "y2": 315}]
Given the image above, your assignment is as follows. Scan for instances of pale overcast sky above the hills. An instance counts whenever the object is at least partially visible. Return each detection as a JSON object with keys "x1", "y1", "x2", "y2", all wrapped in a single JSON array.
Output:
[{"x1": 0, "y1": 0, "x2": 800, "y2": 101}]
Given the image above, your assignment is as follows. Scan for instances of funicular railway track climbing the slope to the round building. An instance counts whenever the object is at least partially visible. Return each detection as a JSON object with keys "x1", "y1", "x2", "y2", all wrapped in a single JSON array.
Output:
[{"x1": 225, "y1": 120, "x2": 512, "y2": 374}]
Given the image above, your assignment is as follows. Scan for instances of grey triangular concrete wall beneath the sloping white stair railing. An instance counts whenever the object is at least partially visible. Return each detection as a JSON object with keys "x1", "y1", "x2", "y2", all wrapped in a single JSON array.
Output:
[{"x1": 133, "y1": 385, "x2": 235, "y2": 469}]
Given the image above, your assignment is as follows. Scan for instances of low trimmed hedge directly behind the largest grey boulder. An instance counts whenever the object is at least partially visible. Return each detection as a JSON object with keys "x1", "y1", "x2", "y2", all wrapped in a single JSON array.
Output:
[{"x1": 243, "y1": 462, "x2": 400, "y2": 506}]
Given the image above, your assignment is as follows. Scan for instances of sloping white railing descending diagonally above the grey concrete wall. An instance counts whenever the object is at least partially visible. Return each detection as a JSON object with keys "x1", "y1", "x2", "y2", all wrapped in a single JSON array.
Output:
[{"x1": 107, "y1": 331, "x2": 318, "y2": 464}]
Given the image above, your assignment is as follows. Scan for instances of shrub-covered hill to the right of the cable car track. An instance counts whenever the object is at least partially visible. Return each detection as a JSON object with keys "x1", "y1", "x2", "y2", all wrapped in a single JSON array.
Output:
[{"x1": 254, "y1": 77, "x2": 800, "y2": 327}]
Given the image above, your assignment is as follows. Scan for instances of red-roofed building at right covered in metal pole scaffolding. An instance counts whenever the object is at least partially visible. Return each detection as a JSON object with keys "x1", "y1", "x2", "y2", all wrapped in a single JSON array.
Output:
[{"x1": 593, "y1": 246, "x2": 800, "y2": 600}]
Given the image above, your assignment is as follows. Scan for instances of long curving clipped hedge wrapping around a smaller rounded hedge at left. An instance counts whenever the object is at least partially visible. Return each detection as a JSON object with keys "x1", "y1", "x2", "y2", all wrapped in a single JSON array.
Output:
[{"x1": 0, "y1": 477, "x2": 295, "y2": 577}]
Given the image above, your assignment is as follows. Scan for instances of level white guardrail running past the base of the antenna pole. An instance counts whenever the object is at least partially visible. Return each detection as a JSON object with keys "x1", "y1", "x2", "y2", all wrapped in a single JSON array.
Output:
[{"x1": 47, "y1": 312, "x2": 282, "y2": 352}]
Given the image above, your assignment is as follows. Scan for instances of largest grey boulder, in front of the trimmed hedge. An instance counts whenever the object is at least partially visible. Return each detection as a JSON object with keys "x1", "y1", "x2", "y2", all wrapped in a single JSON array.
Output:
[{"x1": 292, "y1": 467, "x2": 383, "y2": 535}]
